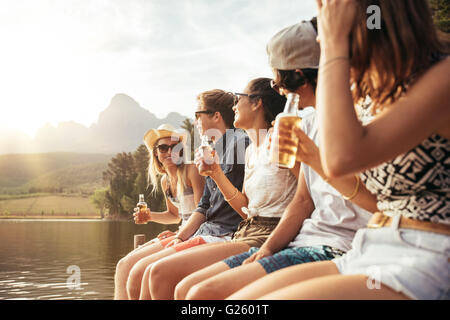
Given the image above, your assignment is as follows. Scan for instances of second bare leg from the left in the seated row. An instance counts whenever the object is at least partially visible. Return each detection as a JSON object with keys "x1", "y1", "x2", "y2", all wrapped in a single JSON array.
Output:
[{"x1": 126, "y1": 248, "x2": 176, "y2": 300}]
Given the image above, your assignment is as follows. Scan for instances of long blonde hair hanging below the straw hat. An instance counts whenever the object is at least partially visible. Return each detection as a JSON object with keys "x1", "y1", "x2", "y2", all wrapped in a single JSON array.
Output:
[{"x1": 147, "y1": 140, "x2": 187, "y2": 195}]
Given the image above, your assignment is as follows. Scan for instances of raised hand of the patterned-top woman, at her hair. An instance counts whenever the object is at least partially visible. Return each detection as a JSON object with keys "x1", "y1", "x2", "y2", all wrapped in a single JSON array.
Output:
[{"x1": 316, "y1": 0, "x2": 358, "y2": 53}]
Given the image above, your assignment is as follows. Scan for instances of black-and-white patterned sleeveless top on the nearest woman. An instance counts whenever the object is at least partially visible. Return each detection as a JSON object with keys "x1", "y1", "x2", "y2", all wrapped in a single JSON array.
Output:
[{"x1": 360, "y1": 134, "x2": 450, "y2": 224}]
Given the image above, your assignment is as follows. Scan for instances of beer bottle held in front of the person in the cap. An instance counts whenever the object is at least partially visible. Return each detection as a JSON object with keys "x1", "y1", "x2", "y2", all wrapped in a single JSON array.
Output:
[{"x1": 270, "y1": 92, "x2": 302, "y2": 169}]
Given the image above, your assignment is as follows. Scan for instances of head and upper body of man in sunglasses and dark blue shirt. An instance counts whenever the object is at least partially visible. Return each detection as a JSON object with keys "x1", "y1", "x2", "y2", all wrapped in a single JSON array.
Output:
[{"x1": 164, "y1": 89, "x2": 250, "y2": 251}]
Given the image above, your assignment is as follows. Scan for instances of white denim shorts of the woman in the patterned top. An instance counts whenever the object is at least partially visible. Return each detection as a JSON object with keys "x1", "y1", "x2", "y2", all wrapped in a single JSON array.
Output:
[{"x1": 333, "y1": 216, "x2": 450, "y2": 300}]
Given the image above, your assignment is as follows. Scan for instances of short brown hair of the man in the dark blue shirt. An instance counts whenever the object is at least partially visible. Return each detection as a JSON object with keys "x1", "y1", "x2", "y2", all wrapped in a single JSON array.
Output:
[{"x1": 197, "y1": 89, "x2": 234, "y2": 129}]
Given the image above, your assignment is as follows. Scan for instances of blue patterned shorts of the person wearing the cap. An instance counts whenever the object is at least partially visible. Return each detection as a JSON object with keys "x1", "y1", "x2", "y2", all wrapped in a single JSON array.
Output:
[{"x1": 223, "y1": 246, "x2": 344, "y2": 273}]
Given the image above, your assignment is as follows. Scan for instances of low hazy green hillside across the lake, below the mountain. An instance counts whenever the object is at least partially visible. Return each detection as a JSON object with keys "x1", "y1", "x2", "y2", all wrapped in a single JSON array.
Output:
[{"x1": 0, "y1": 152, "x2": 113, "y2": 193}]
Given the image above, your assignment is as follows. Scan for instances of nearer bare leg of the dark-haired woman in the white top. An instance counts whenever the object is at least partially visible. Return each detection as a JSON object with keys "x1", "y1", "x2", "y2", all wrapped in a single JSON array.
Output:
[{"x1": 149, "y1": 242, "x2": 250, "y2": 300}]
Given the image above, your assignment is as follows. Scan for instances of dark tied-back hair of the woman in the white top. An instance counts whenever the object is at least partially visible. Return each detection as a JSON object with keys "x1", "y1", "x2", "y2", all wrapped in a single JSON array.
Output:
[{"x1": 248, "y1": 78, "x2": 286, "y2": 126}]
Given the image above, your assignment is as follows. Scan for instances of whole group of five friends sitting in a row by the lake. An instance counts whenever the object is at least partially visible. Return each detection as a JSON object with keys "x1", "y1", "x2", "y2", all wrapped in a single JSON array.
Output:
[{"x1": 115, "y1": 0, "x2": 450, "y2": 299}]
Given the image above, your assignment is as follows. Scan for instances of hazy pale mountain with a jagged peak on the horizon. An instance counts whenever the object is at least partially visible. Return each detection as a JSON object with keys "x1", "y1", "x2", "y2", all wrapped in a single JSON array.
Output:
[{"x1": 0, "y1": 94, "x2": 190, "y2": 154}]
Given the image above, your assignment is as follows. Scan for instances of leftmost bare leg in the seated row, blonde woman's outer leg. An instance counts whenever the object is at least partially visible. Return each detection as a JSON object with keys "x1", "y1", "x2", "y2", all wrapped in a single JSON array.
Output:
[{"x1": 114, "y1": 242, "x2": 164, "y2": 300}]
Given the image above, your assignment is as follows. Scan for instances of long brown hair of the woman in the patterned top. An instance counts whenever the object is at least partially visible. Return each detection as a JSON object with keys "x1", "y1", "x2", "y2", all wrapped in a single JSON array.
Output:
[{"x1": 350, "y1": 0, "x2": 449, "y2": 113}]
